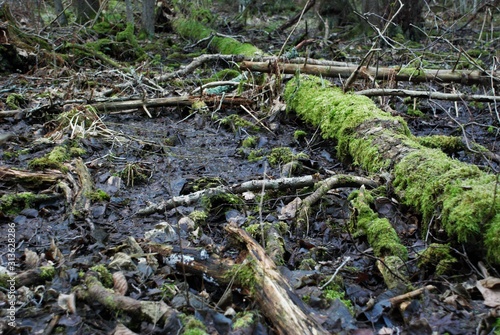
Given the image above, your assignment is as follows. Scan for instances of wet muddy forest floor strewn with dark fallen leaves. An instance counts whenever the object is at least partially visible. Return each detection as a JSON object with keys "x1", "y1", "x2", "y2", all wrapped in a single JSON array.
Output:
[{"x1": 0, "y1": 1, "x2": 500, "y2": 335}]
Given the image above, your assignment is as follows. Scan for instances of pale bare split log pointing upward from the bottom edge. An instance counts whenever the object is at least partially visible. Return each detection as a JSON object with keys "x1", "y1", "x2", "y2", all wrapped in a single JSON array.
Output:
[{"x1": 226, "y1": 225, "x2": 330, "y2": 335}]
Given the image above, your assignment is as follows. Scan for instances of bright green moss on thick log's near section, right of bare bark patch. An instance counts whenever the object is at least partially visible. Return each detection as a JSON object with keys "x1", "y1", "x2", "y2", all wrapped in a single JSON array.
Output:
[{"x1": 394, "y1": 149, "x2": 500, "y2": 263}]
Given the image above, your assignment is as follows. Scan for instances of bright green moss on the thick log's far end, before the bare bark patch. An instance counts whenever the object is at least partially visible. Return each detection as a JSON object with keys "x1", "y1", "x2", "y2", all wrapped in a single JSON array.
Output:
[{"x1": 284, "y1": 75, "x2": 411, "y2": 172}]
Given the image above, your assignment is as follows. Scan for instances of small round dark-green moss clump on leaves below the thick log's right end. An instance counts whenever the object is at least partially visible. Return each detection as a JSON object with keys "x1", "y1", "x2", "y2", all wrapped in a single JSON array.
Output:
[{"x1": 418, "y1": 243, "x2": 457, "y2": 275}]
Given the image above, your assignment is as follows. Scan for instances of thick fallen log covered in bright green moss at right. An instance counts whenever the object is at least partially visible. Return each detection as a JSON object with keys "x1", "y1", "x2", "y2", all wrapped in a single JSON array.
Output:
[{"x1": 284, "y1": 75, "x2": 500, "y2": 264}]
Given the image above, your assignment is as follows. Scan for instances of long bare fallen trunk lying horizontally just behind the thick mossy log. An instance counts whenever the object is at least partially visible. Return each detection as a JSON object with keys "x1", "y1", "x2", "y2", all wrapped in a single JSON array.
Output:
[{"x1": 240, "y1": 61, "x2": 500, "y2": 85}]
